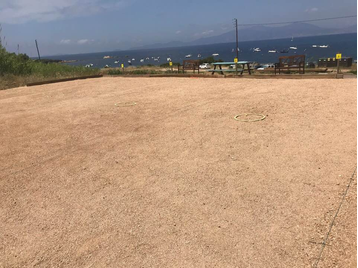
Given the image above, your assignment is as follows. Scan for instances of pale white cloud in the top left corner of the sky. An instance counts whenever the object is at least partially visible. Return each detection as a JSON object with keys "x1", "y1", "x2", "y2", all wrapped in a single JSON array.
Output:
[{"x1": 0, "y1": 0, "x2": 135, "y2": 24}]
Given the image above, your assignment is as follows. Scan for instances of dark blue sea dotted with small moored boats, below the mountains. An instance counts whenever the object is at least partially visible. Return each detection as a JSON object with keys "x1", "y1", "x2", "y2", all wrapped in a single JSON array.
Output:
[{"x1": 44, "y1": 33, "x2": 357, "y2": 68}]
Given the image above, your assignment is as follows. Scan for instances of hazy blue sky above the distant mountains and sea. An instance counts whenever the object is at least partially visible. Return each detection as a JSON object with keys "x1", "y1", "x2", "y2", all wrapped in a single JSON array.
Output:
[{"x1": 0, "y1": 0, "x2": 357, "y2": 56}]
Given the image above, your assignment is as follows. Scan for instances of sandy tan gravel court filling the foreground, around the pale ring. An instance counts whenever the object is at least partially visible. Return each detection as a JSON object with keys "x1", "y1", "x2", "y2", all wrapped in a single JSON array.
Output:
[{"x1": 0, "y1": 77, "x2": 357, "y2": 267}]
